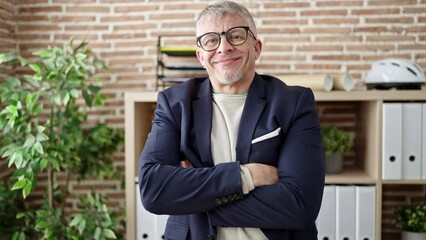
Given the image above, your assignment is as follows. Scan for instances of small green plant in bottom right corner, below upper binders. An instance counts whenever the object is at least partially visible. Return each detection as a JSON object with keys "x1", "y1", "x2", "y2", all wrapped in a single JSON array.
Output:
[{"x1": 394, "y1": 203, "x2": 426, "y2": 240}]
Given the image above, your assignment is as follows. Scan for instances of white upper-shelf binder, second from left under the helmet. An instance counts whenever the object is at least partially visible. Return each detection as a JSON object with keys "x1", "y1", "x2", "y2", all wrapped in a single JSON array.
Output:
[{"x1": 402, "y1": 103, "x2": 422, "y2": 179}]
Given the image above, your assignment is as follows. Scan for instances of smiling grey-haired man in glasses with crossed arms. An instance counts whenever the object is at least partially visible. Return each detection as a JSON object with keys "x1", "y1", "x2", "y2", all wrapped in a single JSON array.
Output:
[{"x1": 139, "y1": 2, "x2": 324, "y2": 240}]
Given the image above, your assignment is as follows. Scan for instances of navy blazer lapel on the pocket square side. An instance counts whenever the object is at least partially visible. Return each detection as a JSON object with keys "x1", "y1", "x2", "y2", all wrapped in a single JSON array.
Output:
[{"x1": 236, "y1": 74, "x2": 266, "y2": 164}]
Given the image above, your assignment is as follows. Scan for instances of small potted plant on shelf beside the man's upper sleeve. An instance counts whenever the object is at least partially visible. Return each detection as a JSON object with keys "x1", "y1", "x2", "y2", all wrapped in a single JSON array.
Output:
[{"x1": 321, "y1": 125, "x2": 353, "y2": 174}]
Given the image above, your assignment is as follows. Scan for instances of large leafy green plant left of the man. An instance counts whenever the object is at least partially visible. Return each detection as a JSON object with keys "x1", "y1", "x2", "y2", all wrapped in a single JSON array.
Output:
[{"x1": 0, "y1": 40, "x2": 123, "y2": 240}]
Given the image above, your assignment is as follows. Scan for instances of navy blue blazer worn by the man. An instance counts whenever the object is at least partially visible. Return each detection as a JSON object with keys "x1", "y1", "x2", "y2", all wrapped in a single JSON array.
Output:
[{"x1": 139, "y1": 74, "x2": 324, "y2": 240}]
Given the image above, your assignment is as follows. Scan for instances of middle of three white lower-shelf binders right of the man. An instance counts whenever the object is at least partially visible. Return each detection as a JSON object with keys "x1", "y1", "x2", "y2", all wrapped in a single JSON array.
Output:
[{"x1": 336, "y1": 186, "x2": 356, "y2": 240}]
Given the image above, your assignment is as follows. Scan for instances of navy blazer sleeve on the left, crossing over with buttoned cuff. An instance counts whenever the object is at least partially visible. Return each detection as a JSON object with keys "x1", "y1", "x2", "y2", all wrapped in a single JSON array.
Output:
[{"x1": 138, "y1": 92, "x2": 243, "y2": 215}]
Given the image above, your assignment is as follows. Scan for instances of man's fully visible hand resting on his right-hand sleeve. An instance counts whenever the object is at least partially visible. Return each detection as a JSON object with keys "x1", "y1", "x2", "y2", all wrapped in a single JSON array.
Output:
[{"x1": 243, "y1": 163, "x2": 278, "y2": 187}]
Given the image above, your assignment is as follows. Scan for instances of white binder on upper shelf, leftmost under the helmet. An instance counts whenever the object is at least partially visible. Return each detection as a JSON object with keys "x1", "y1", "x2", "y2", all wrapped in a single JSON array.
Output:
[{"x1": 382, "y1": 103, "x2": 402, "y2": 179}]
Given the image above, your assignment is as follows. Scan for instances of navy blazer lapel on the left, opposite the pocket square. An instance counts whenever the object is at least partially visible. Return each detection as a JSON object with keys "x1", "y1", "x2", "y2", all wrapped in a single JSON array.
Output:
[{"x1": 193, "y1": 79, "x2": 214, "y2": 167}]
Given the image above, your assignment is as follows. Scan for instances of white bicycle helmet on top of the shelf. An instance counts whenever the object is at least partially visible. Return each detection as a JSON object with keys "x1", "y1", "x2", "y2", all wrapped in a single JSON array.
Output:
[{"x1": 364, "y1": 58, "x2": 426, "y2": 89}]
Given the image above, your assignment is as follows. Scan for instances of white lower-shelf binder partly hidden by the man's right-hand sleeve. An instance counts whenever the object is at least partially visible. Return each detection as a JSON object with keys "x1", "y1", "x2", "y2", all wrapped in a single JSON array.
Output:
[{"x1": 316, "y1": 185, "x2": 336, "y2": 240}]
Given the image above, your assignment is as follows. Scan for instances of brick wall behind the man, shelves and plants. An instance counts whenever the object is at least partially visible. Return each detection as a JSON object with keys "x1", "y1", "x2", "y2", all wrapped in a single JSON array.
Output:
[{"x1": 0, "y1": 0, "x2": 426, "y2": 237}]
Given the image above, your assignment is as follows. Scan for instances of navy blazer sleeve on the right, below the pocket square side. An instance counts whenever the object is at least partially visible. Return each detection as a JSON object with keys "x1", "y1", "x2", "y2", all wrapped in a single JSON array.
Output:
[{"x1": 209, "y1": 89, "x2": 325, "y2": 230}]
